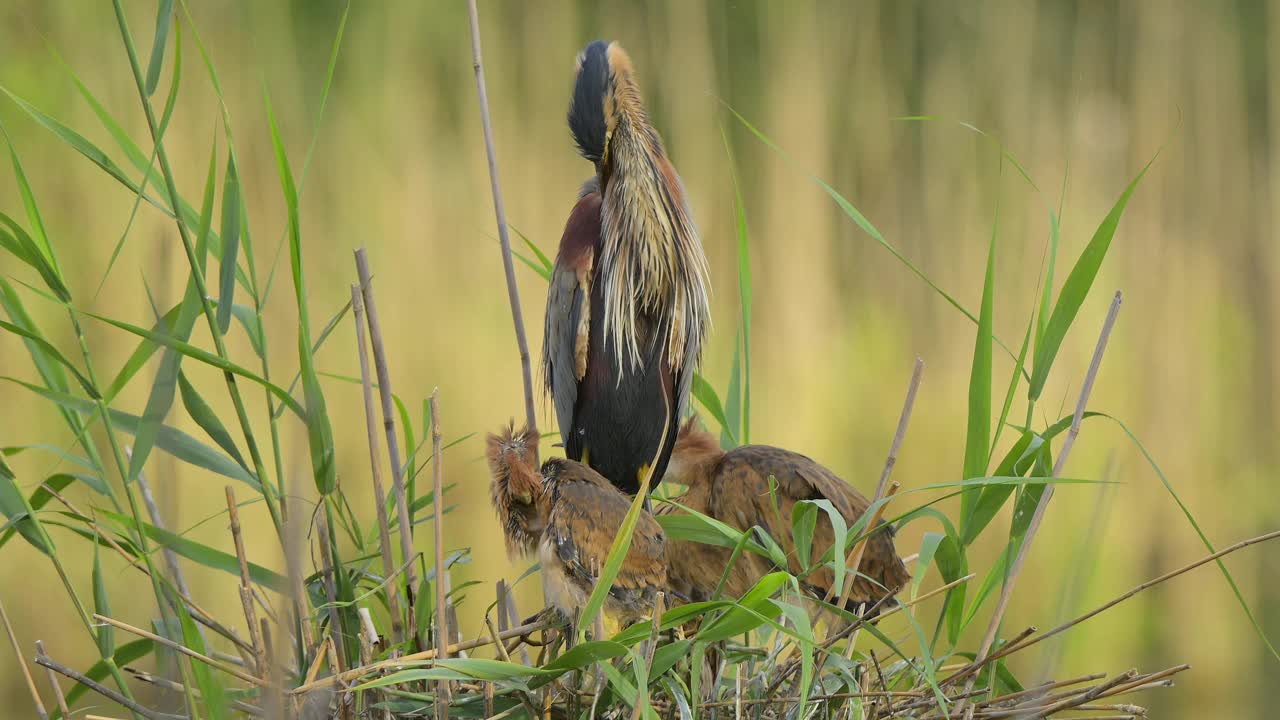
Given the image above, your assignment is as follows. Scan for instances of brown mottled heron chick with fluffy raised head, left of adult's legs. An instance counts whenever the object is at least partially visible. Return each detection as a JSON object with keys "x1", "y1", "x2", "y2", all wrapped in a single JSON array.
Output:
[{"x1": 486, "y1": 428, "x2": 667, "y2": 624}]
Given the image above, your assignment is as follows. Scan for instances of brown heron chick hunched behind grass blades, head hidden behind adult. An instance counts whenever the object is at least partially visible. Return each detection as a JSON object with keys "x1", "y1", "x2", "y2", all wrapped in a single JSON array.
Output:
[{"x1": 658, "y1": 419, "x2": 910, "y2": 610}]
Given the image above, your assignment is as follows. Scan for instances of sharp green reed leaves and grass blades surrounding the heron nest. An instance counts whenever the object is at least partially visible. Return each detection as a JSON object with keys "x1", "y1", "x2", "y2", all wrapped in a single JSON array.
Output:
[{"x1": 0, "y1": 0, "x2": 1275, "y2": 720}]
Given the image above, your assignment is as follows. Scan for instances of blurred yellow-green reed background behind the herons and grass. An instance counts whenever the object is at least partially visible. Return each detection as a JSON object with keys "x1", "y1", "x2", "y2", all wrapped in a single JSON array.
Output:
[{"x1": 0, "y1": 0, "x2": 1280, "y2": 717}]
